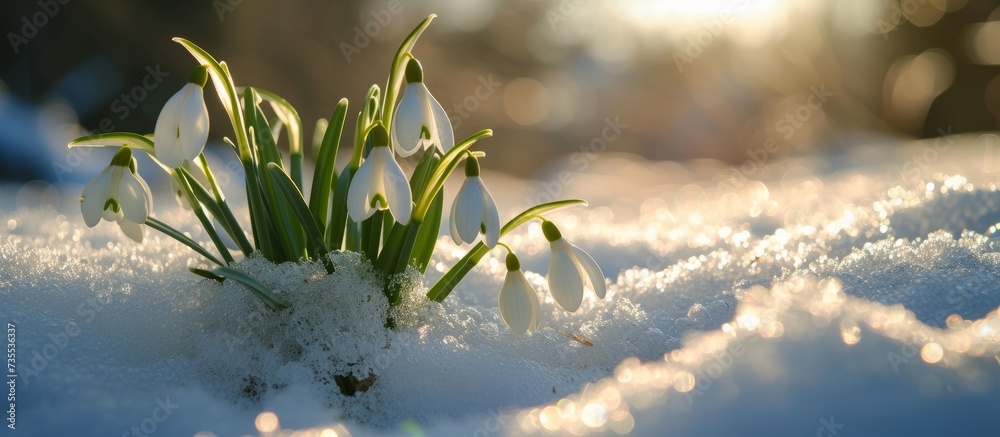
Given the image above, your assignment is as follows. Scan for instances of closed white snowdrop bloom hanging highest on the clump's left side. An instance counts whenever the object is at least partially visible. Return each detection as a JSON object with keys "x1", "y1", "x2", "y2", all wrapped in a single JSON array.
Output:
[{"x1": 153, "y1": 66, "x2": 208, "y2": 168}]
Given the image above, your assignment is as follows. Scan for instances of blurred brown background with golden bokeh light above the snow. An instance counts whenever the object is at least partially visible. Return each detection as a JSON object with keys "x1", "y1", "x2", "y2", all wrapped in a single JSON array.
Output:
[{"x1": 0, "y1": 0, "x2": 1000, "y2": 184}]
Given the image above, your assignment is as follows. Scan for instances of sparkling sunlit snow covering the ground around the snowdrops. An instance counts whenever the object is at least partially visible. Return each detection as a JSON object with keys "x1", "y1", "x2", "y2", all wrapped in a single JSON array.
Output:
[{"x1": 0, "y1": 137, "x2": 1000, "y2": 436}]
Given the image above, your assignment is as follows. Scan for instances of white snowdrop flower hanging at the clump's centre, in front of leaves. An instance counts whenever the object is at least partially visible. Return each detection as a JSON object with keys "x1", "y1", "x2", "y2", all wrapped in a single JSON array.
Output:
[{"x1": 347, "y1": 124, "x2": 413, "y2": 223}]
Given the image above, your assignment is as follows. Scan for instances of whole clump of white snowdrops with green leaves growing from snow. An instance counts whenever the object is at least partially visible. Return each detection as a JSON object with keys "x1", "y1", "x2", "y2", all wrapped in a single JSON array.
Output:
[{"x1": 69, "y1": 15, "x2": 605, "y2": 334}]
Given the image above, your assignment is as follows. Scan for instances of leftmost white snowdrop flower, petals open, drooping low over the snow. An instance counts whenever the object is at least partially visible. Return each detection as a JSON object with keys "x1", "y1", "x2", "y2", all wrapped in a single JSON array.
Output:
[{"x1": 80, "y1": 147, "x2": 153, "y2": 243}]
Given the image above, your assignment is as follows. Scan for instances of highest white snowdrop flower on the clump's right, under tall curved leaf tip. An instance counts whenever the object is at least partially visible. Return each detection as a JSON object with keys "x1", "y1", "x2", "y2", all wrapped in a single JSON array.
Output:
[{"x1": 392, "y1": 59, "x2": 455, "y2": 158}]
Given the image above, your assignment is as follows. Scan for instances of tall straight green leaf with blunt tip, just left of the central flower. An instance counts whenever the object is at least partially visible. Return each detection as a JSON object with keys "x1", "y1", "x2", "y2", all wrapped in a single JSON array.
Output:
[{"x1": 309, "y1": 99, "x2": 347, "y2": 229}]
